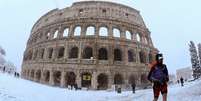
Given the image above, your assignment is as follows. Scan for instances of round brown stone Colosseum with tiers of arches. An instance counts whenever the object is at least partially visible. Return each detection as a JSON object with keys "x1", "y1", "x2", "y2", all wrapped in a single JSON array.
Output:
[{"x1": 21, "y1": 1, "x2": 158, "y2": 90}]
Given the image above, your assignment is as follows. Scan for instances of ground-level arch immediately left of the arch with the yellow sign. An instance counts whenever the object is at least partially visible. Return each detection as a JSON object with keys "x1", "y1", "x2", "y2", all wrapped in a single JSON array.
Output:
[{"x1": 65, "y1": 72, "x2": 76, "y2": 86}]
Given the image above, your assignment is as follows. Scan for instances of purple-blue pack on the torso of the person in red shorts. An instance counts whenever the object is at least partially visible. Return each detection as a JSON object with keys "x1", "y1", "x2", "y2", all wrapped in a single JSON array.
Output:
[{"x1": 151, "y1": 65, "x2": 166, "y2": 83}]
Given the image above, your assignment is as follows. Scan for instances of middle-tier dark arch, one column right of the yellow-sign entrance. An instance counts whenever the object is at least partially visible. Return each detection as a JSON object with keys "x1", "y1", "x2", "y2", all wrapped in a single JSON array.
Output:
[{"x1": 98, "y1": 48, "x2": 108, "y2": 60}]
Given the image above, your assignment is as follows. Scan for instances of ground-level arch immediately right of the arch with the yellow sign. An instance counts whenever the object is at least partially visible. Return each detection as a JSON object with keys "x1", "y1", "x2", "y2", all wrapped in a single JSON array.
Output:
[{"x1": 97, "y1": 74, "x2": 108, "y2": 90}]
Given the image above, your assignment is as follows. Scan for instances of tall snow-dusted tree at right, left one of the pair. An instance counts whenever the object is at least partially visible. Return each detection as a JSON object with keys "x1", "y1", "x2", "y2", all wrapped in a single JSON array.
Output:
[{"x1": 189, "y1": 41, "x2": 201, "y2": 79}]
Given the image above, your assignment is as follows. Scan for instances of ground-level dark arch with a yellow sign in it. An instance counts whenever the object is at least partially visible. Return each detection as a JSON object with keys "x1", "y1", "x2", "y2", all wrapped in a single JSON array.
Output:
[{"x1": 82, "y1": 73, "x2": 92, "y2": 88}]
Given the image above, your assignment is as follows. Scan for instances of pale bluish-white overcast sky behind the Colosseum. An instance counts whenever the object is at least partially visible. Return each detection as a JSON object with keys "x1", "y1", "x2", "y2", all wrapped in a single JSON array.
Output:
[{"x1": 0, "y1": 0, "x2": 201, "y2": 73}]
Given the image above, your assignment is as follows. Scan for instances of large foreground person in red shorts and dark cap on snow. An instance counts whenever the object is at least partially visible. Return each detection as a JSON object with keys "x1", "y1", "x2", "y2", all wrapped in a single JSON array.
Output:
[{"x1": 148, "y1": 54, "x2": 169, "y2": 101}]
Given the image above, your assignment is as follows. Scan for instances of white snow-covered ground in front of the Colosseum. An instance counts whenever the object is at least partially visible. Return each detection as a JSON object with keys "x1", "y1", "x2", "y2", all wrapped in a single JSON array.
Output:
[{"x1": 0, "y1": 73, "x2": 201, "y2": 101}]
